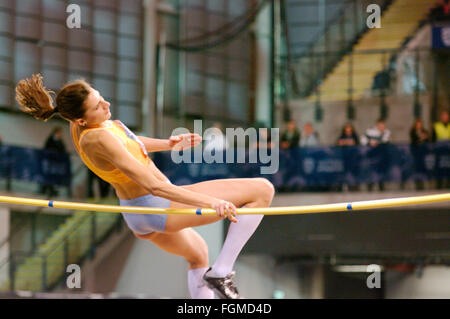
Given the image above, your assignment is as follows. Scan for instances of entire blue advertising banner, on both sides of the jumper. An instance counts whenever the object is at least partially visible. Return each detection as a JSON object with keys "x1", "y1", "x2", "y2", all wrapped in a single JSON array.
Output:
[{"x1": 0, "y1": 142, "x2": 450, "y2": 190}]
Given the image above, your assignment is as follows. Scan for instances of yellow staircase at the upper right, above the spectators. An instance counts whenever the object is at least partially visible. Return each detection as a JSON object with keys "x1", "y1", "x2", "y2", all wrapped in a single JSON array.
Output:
[{"x1": 309, "y1": 0, "x2": 439, "y2": 101}]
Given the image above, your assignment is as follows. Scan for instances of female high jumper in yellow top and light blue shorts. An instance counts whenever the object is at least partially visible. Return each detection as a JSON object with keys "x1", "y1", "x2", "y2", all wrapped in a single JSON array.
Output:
[{"x1": 16, "y1": 74, "x2": 274, "y2": 299}]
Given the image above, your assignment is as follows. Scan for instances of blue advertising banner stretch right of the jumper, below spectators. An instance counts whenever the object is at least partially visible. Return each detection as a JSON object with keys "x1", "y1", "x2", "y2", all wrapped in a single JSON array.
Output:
[{"x1": 154, "y1": 142, "x2": 450, "y2": 190}]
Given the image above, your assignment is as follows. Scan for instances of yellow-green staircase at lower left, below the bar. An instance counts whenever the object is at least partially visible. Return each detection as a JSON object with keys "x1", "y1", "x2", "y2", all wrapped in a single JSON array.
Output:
[{"x1": 0, "y1": 202, "x2": 122, "y2": 291}]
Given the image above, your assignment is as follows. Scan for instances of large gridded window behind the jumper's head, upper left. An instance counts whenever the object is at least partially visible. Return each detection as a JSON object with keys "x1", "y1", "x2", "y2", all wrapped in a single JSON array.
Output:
[{"x1": 0, "y1": 0, "x2": 143, "y2": 129}]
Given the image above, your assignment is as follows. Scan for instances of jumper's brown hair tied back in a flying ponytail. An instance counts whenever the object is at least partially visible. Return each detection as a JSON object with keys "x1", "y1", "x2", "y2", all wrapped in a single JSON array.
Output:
[{"x1": 16, "y1": 74, "x2": 91, "y2": 122}]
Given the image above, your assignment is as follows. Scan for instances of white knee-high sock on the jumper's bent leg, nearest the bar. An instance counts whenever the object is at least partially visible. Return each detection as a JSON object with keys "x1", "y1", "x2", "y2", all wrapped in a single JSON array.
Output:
[{"x1": 210, "y1": 215, "x2": 264, "y2": 277}]
